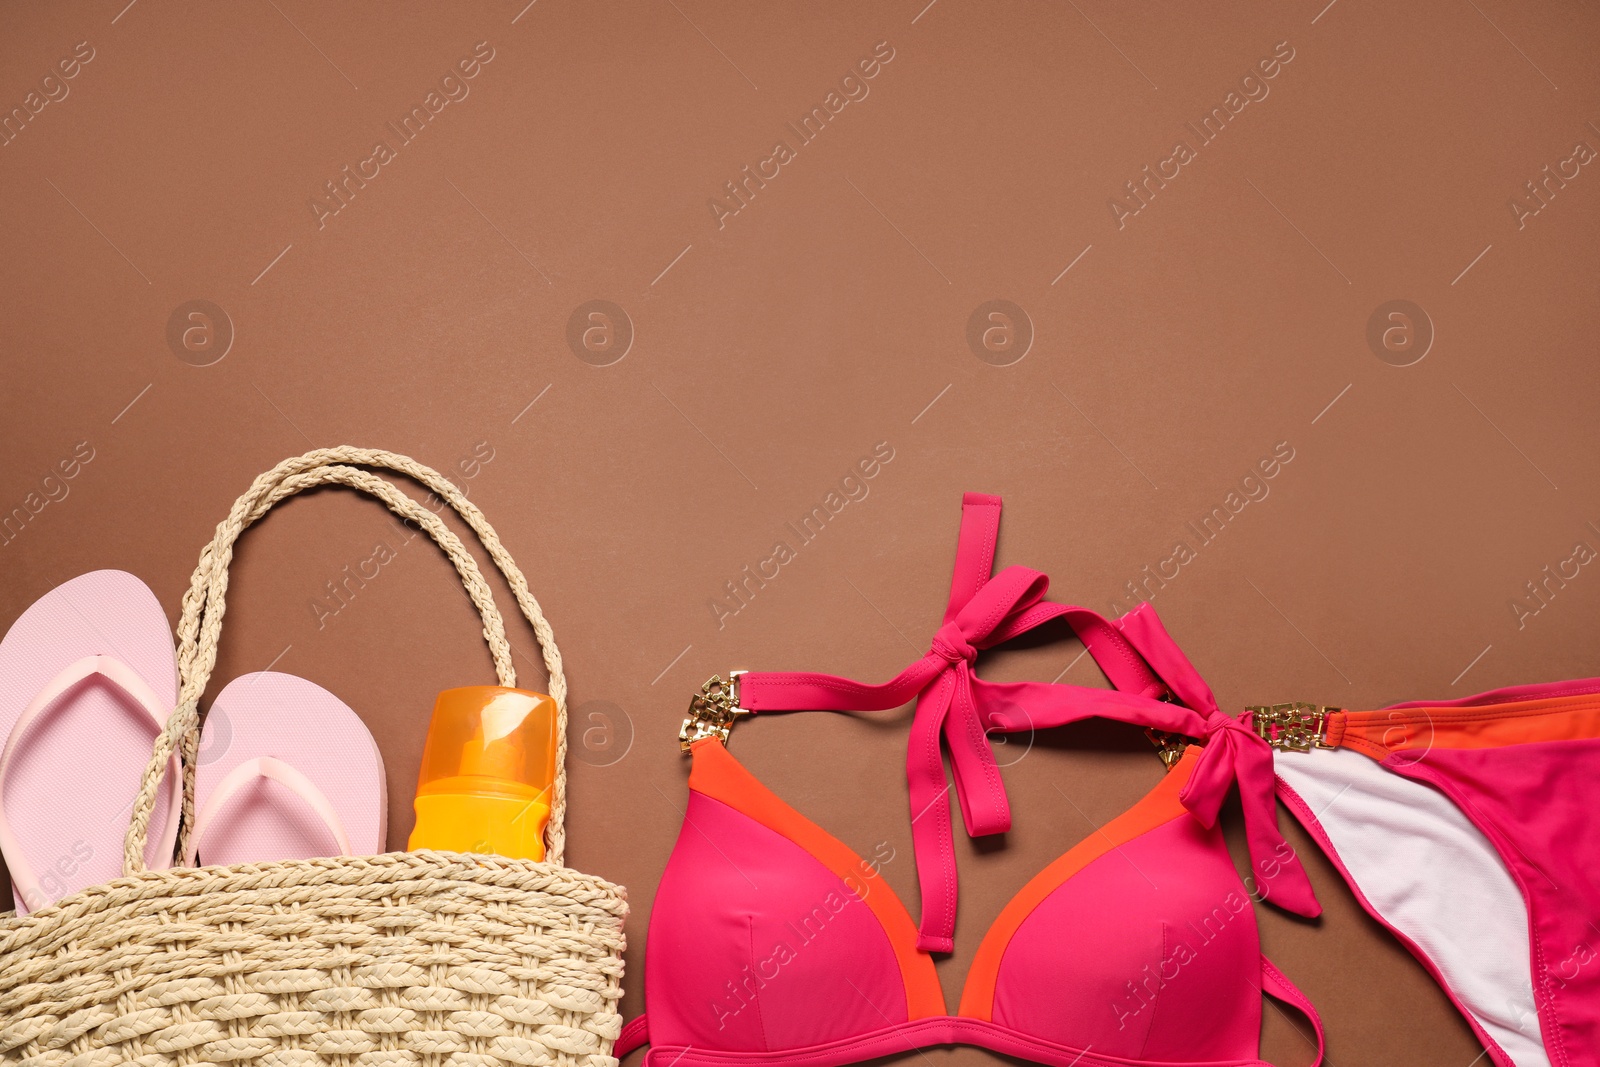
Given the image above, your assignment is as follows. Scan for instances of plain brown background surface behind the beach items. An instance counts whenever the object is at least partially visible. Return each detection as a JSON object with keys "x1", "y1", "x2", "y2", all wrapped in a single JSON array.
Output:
[{"x1": 0, "y1": 0, "x2": 1600, "y2": 1067}]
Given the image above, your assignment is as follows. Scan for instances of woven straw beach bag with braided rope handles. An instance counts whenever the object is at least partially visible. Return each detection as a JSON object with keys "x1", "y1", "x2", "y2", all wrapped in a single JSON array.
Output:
[{"x1": 0, "y1": 448, "x2": 627, "y2": 1067}]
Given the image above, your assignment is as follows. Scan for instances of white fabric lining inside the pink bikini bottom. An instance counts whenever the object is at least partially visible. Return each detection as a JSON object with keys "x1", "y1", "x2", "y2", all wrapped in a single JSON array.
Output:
[{"x1": 1275, "y1": 749, "x2": 1550, "y2": 1067}]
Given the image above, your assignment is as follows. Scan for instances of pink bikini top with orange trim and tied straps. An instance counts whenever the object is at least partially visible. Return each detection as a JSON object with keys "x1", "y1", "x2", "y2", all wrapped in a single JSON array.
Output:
[{"x1": 616, "y1": 493, "x2": 1322, "y2": 1067}]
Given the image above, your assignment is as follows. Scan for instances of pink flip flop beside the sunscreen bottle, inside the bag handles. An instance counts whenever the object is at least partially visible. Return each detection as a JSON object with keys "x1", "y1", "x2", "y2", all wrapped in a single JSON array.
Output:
[{"x1": 184, "y1": 670, "x2": 389, "y2": 865}]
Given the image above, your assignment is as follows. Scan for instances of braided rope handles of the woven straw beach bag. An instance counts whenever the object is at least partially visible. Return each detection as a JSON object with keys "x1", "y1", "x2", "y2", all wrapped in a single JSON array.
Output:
[{"x1": 123, "y1": 446, "x2": 566, "y2": 873}]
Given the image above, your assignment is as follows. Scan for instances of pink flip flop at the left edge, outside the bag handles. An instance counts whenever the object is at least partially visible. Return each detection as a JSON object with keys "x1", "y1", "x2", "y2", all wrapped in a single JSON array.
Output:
[{"x1": 0, "y1": 571, "x2": 182, "y2": 913}]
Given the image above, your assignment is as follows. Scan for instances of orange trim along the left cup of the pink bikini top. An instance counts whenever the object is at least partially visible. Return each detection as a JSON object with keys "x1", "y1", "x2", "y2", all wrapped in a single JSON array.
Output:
[{"x1": 690, "y1": 737, "x2": 944, "y2": 1019}]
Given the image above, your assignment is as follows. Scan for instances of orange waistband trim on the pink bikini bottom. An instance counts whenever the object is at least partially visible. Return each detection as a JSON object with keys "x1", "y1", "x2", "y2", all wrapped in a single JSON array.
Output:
[{"x1": 1328, "y1": 694, "x2": 1600, "y2": 760}]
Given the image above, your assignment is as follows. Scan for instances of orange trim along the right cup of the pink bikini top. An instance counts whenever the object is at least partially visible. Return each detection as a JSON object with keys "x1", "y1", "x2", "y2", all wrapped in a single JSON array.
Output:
[{"x1": 958, "y1": 745, "x2": 1200, "y2": 1022}]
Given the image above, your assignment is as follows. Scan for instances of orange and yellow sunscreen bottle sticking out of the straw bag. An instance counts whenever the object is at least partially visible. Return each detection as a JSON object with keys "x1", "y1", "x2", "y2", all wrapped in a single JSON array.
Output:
[{"x1": 406, "y1": 685, "x2": 557, "y2": 859}]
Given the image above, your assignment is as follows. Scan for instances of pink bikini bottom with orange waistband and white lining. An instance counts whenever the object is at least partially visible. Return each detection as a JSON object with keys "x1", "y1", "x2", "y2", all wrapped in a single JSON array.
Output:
[{"x1": 1273, "y1": 678, "x2": 1600, "y2": 1067}]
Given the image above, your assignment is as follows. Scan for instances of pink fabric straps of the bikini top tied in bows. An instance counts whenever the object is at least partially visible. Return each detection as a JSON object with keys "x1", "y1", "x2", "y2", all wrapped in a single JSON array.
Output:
[{"x1": 739, "y1": 493, "x2": 1320, "y2": 952}]
